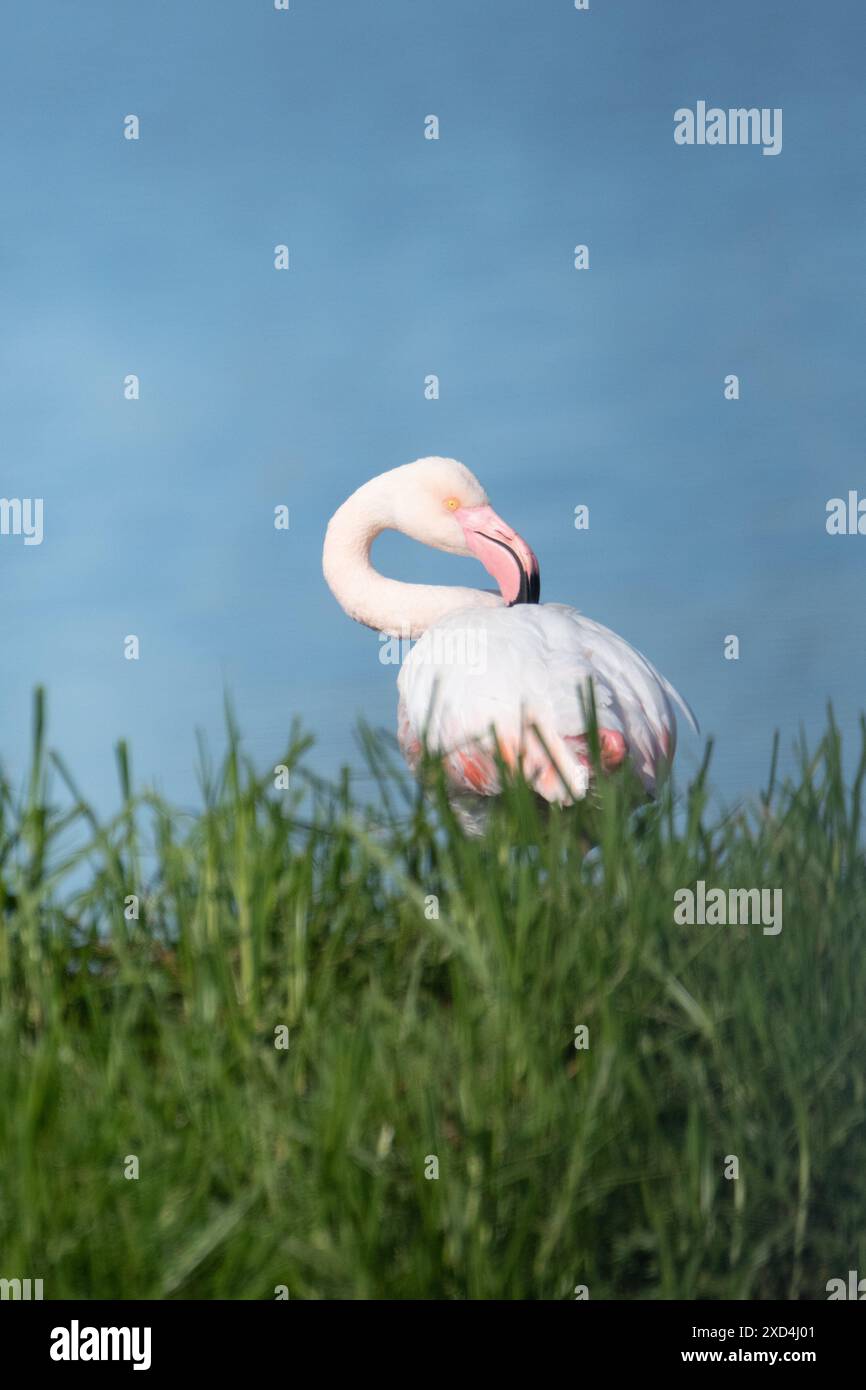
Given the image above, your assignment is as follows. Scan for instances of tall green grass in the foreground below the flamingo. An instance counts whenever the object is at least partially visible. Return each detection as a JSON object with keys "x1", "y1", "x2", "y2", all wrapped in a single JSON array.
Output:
[{"x1": 0, "y1": 696, "x2": 866, "y2": 1298}]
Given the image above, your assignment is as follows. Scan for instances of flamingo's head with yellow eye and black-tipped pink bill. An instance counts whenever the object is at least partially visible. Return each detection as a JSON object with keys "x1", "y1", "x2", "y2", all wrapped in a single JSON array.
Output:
[{"x1": 386, "y1": 459, "x2": 541, "y2": 605}]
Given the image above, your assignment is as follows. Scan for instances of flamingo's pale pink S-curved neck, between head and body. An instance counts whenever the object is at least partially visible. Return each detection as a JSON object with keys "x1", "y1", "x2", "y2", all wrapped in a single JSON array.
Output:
[{"x1": 322, "y1": 478, "x2": 502, "y2": 638}]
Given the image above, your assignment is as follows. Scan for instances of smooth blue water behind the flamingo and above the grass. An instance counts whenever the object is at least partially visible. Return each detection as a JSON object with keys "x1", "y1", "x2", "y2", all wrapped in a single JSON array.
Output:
[{"x1": 0, "y1": 0, "x2": 866, "y2": 809}]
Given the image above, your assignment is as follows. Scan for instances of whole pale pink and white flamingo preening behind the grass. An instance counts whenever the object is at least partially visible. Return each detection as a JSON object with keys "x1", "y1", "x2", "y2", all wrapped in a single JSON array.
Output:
[{"x1": 322, "y1": 457, "x2": 696, "y2": 806}]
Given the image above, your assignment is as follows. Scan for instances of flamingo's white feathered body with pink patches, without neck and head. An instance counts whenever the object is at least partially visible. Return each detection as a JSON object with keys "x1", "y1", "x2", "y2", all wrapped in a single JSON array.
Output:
[{"x1": 398, "y1": 603, "x2": 694, "y2": 803}]
